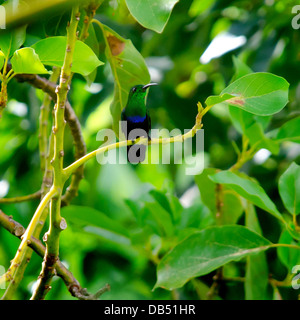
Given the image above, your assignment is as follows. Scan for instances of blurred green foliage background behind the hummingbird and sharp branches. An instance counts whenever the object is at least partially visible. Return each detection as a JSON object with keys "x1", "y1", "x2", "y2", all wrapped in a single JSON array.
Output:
[{"x1": 0, "y1": 0, "x2": 300, "y2": 299}]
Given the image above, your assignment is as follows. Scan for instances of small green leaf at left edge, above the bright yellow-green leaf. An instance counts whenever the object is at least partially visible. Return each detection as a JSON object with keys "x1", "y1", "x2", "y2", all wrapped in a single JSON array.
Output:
[{"x1": 0, "y1": 26, "x2": 26, "y2": 58}]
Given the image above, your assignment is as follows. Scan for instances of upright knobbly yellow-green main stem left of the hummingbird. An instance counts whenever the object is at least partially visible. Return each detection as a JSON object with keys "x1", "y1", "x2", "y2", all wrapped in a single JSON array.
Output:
[{"x1": 31, "y1": 4, "x2": 80, "y2": 300}]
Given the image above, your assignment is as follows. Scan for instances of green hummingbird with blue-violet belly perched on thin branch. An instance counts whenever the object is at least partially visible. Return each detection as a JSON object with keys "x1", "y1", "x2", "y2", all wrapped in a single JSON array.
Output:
[{"x1": 121, "y1": 83, "x2": 157, "y2": 163}]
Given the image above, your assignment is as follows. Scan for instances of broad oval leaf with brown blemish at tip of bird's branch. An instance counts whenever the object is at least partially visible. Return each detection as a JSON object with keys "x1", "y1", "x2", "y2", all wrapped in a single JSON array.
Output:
[{"x1": 206, "y1": 72, "x2": 289, "y2": 116}]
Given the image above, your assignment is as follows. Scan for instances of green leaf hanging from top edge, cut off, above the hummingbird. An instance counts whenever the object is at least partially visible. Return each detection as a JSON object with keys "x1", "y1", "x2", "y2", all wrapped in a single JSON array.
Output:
[{"x1": 126, "y1": 0, "x2": 179, "y2": 33}]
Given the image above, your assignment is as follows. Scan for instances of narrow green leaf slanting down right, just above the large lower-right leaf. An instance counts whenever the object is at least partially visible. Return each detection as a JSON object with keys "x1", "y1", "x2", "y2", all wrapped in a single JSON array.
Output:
[{"x1": 210, "y1": 171, "x2": 284, "y2": 222}]
